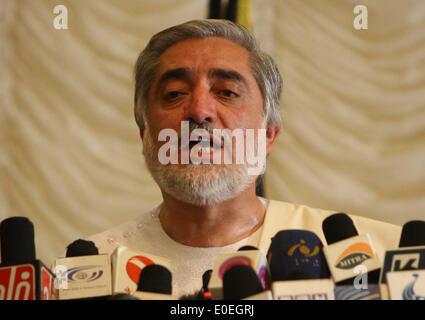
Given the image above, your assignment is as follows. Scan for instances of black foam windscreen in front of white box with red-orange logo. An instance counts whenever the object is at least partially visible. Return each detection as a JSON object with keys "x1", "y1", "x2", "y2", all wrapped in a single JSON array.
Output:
[{"x1": 137, "y1": 264, "x2": 172, "y2": 295}]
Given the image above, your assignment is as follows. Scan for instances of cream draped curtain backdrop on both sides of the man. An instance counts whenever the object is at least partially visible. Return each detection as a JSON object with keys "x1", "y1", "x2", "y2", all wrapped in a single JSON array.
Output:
[{"x1": 0, "y1": 0, "x2": 425, "y2": 264}]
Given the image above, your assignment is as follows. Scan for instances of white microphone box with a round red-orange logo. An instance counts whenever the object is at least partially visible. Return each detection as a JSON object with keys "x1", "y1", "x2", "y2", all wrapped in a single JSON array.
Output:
[{"x1": 111, "y1": 246, "x2": 170, "y2": 294}]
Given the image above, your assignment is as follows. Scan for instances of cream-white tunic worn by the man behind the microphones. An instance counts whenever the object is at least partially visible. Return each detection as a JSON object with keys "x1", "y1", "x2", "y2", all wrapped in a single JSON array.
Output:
[{"x1": 89, "y1": 198, "x2": 401, "y2": 297}]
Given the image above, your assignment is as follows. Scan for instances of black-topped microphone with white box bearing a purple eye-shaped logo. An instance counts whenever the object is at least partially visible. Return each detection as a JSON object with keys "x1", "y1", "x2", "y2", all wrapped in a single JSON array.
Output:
[{"x1": 55, "y1": 239, "x2": 112, "y2": 300}]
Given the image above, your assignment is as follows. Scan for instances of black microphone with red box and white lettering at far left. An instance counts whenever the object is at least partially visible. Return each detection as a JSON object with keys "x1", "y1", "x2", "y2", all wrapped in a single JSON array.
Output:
[{"x1": 0, "y1": 217, "x2": 56, "y2": 300}]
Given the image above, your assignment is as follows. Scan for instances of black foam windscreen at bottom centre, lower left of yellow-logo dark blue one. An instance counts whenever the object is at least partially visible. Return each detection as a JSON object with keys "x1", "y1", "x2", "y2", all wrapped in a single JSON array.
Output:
[{"x1": 223, "y1": 265, "x2": 264, "y2": 300}]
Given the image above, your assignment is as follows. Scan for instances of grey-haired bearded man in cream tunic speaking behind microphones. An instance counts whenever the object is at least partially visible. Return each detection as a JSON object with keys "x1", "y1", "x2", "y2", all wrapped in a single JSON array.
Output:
[{"x1": 91, "y1": 20, "x2": 400, "y2": 296}]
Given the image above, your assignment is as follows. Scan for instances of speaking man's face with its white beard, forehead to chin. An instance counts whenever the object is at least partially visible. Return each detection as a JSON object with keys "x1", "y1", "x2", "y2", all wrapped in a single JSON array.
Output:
[{"x1": 143, "y1": 37, "x2": 276, "y2": 205}]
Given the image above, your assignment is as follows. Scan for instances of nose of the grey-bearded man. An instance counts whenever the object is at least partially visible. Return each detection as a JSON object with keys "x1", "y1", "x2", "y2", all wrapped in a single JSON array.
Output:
[{"x1": 185, "y1": 87, "x2": 217, "y2": 124}]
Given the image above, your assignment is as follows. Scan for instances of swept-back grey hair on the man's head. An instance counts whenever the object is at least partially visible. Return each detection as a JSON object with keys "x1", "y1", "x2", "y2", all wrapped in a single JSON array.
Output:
[{"x1": 134, "y1": 19, "x2": 282, "y2": 129}]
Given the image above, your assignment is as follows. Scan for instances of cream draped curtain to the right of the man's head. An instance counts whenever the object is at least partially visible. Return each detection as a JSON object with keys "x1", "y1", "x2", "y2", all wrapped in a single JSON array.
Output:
[{"x1": 254, "y1": 0, "x2": 425, "y2": 225}]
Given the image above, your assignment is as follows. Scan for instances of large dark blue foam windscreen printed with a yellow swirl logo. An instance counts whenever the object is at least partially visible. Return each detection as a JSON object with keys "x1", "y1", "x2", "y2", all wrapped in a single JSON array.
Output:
[{"x1": 267, "y1": 230, "x2": 331, "y2": 282}]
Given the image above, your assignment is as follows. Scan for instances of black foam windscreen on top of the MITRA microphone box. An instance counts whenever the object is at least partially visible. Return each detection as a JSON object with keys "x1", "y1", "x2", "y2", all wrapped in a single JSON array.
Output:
[{"x1": 322, "y1": 212, "x2": 358, "y2": 245}]
